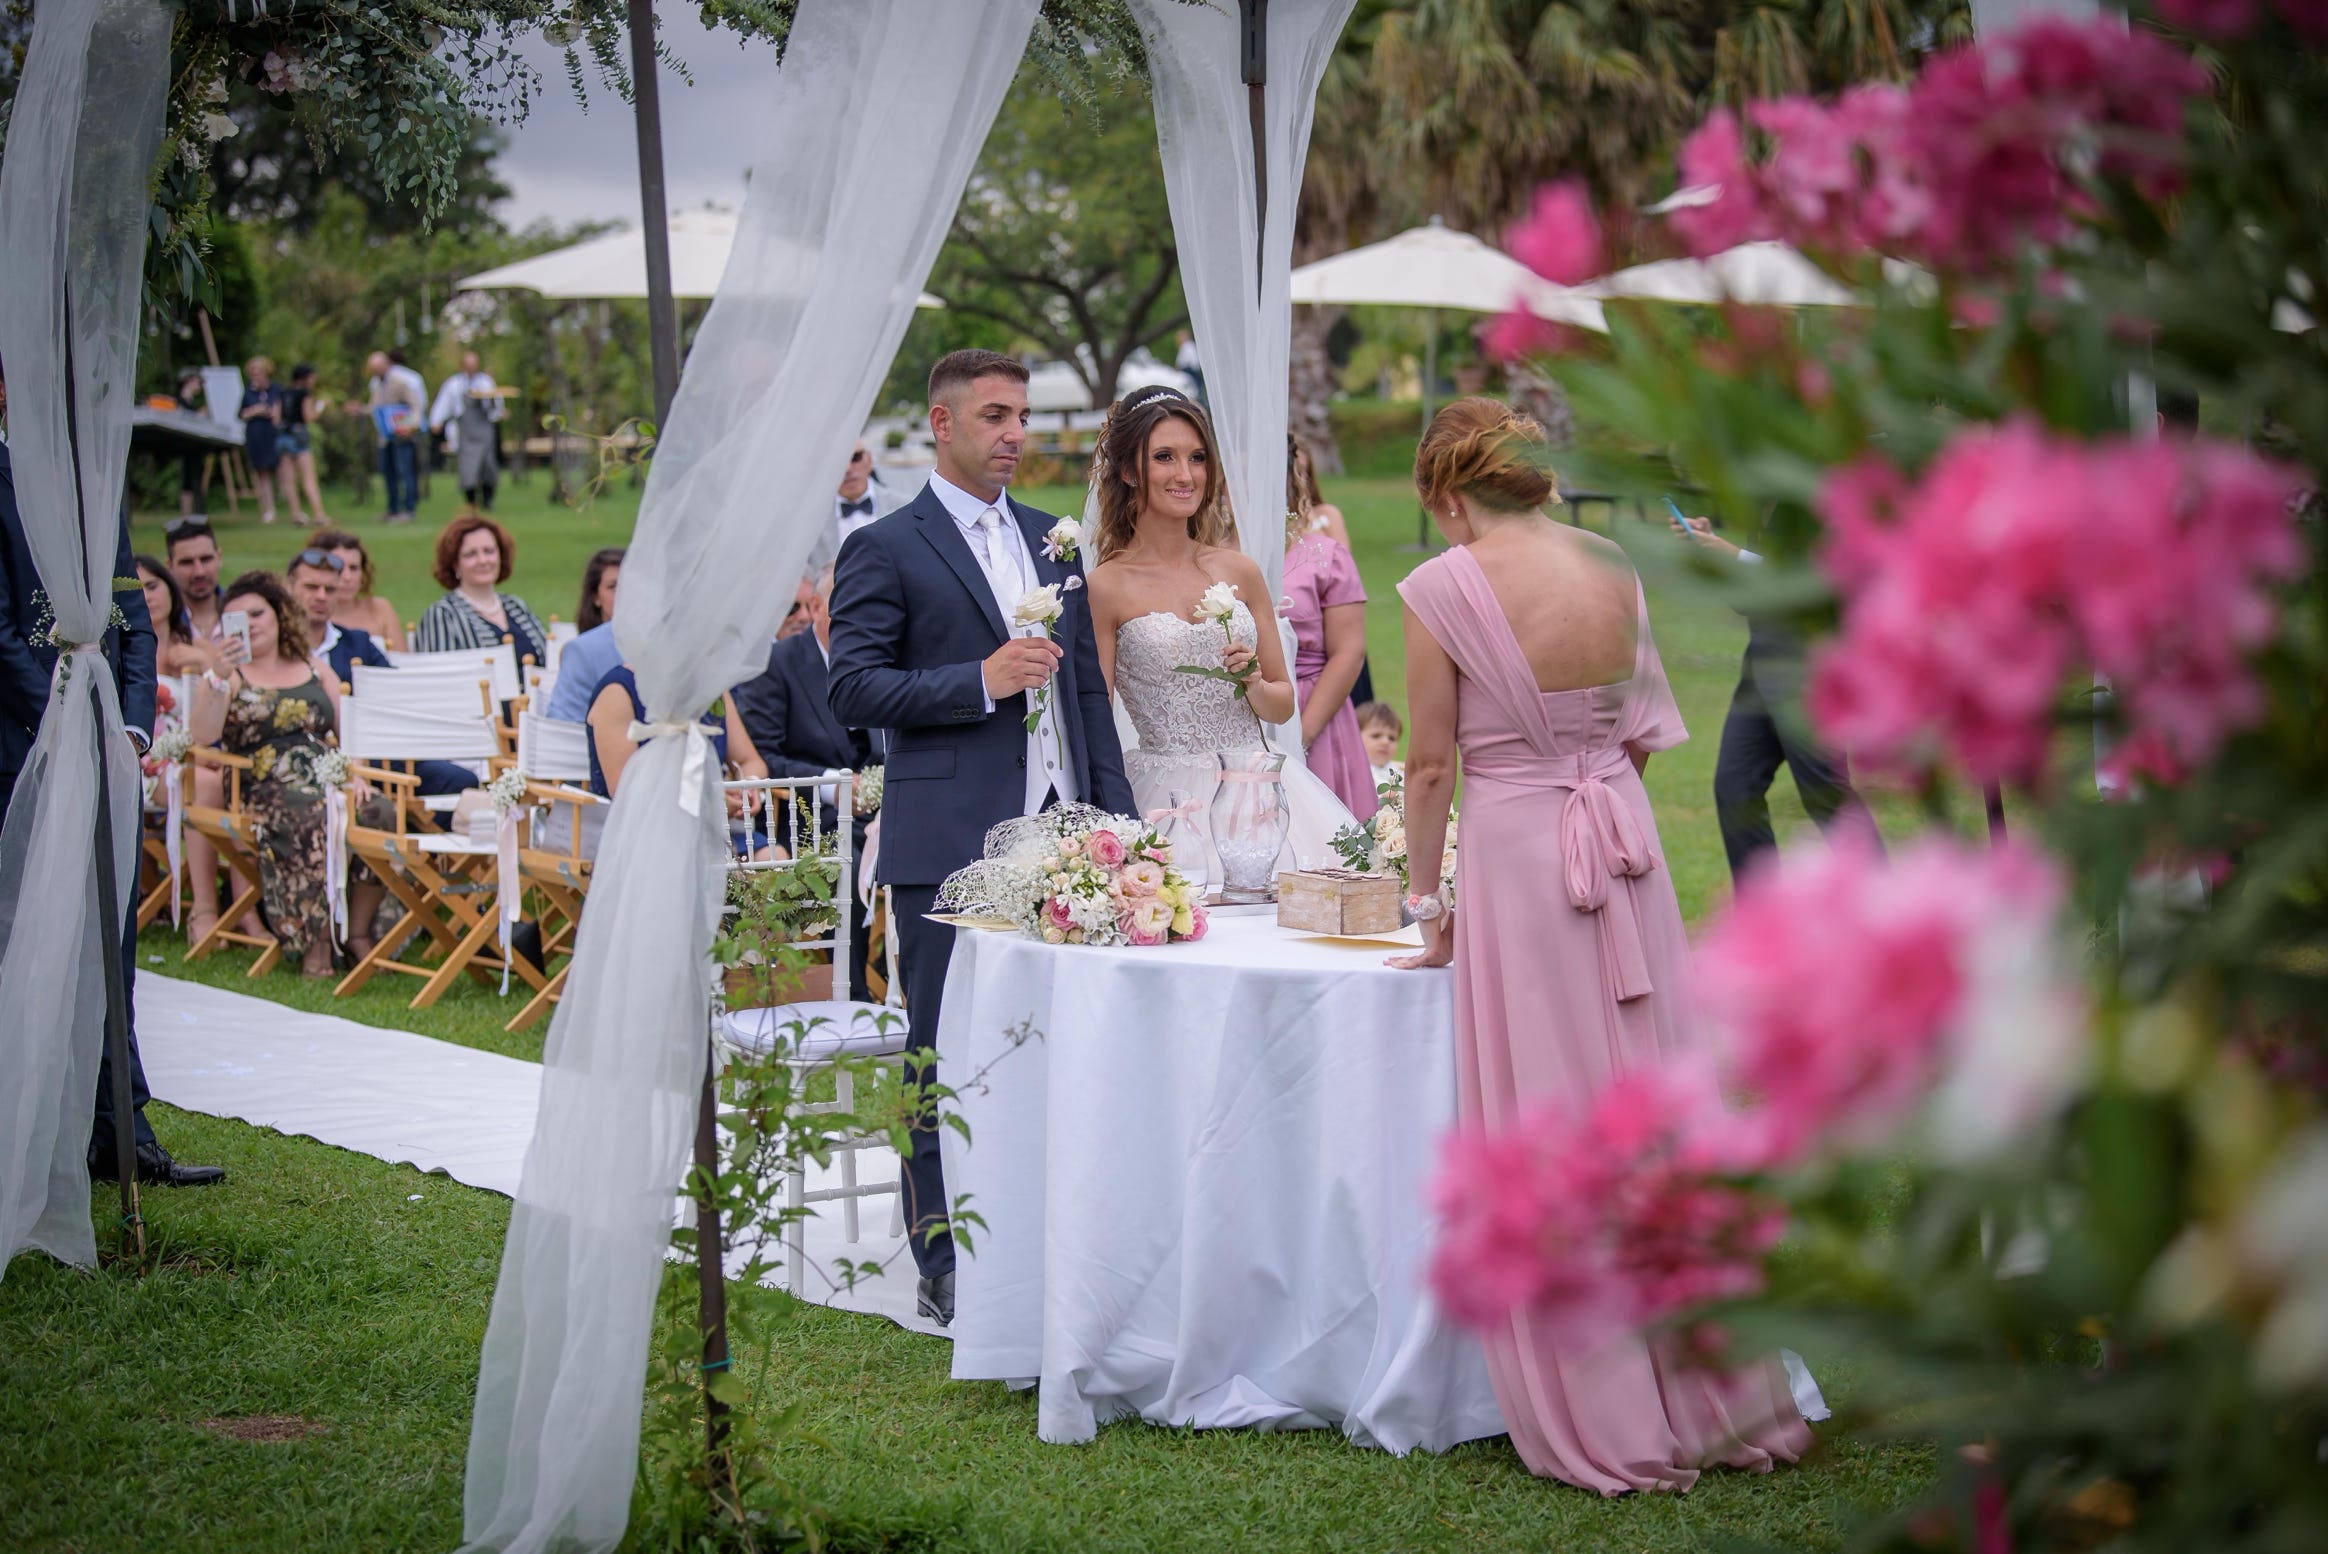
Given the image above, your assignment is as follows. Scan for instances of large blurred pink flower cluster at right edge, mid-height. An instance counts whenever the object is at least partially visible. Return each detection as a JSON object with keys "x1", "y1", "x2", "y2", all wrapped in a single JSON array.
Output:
[{"x1": 1807, "y1": 421, "x2": 2302, "y2": 782}]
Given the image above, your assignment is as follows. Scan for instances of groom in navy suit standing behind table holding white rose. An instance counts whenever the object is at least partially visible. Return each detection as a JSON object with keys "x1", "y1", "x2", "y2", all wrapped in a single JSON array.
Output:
[{"x1": 831, "y1": 351, "x2": 1131, "y2": 1324}]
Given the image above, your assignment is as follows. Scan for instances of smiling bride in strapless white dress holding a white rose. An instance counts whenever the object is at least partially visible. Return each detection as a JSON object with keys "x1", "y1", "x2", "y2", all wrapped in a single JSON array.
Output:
[{"x1": 1087, "y1": 389, "x2": 1355, "y2": 882}]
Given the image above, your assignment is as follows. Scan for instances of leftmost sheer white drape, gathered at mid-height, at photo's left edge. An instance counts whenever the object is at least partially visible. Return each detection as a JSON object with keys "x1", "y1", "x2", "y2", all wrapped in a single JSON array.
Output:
[{"x1": 0, "y1": 0, "x2": 170, "y2": 1268}]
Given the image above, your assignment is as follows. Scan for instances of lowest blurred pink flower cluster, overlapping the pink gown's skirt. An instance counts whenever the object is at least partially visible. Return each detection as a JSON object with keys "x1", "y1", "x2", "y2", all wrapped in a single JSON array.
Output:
[{"x1": 1429, "y1": 1063, "x2": 1783, "y2": 1342}]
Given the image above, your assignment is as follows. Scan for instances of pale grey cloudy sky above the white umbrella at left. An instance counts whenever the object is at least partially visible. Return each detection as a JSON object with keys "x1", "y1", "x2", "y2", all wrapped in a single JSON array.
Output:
[{"x1": 498, "y1": 7, "x2": 775, "y2": 228}]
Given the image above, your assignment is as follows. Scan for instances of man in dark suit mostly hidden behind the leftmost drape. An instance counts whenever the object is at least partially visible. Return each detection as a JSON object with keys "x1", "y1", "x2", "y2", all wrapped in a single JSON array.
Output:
[{"x1": 0, "y1": 355, "x2": 226, "y2": 1186}]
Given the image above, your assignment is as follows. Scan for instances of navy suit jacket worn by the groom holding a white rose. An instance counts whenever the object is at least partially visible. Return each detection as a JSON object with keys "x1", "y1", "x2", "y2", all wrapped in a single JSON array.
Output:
[{"x1": 831, "y1": 486, "x2": 1131, "y2": 884}]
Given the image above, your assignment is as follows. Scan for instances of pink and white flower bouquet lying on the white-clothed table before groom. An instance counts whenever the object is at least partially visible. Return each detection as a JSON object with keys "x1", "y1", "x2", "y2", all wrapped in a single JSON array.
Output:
[{"x1": 938, "y1": 805, "x2": 1206, "y2": 947}]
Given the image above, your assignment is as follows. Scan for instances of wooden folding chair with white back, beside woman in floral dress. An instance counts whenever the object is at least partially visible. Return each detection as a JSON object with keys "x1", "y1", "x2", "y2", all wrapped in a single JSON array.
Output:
[{"x1": 335, "y1": 665, "x2": 542, "y2": 1010}]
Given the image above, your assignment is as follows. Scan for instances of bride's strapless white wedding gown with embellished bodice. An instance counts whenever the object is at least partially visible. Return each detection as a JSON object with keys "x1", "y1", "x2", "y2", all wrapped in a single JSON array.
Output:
[{"x1": 1115, "y1": 605, "x2": 1357, "y2": 884}]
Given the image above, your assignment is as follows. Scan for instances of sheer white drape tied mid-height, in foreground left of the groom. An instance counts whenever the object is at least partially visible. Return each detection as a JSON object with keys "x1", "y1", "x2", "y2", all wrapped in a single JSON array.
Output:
[{"x1": 466, "y1": 0, "x2": 1038, "y2": 1552}]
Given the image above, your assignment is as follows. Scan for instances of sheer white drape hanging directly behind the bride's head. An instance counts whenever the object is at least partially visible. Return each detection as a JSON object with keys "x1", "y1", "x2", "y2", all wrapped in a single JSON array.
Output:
[{"x1": 1129, "y1": 0, "x2": 1353, "y2": 761}]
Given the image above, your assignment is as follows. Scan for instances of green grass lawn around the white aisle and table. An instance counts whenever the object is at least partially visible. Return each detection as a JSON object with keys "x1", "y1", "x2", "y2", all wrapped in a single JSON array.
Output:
[{"x1": 31, "y1": 455, "x2": 1964, "y2": 1554}]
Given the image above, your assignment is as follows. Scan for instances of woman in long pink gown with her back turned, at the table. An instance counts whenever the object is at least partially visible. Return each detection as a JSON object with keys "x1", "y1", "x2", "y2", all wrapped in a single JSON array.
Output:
[{"x1": 1399, "y1": 400, "x2": 1811, "y2": 1494}]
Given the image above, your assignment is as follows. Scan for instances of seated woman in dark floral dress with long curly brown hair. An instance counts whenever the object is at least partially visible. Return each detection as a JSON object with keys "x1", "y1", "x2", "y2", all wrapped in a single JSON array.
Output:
[{"x1": 219, "y1": 572, "x2": 391, "y2": 977}]
